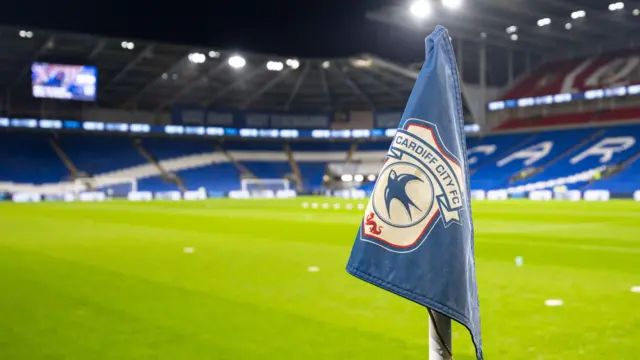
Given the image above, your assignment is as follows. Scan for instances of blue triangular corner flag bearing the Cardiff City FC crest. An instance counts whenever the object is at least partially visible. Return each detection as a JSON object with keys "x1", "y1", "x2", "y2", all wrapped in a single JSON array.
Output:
[{"x1": 347, "y1": 26, "x2": 482, "y2": 360}]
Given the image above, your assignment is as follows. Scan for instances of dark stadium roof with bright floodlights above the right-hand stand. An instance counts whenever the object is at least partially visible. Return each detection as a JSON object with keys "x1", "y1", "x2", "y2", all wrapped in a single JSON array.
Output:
[{"x1": 367, "y1": 0, "x2": 640, "y2": 58}]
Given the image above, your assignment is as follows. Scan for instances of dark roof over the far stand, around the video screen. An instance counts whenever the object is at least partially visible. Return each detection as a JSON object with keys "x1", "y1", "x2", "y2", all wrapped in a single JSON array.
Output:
[{"x1": 0, "y1": 27, "x2": 424, "y2": 112}]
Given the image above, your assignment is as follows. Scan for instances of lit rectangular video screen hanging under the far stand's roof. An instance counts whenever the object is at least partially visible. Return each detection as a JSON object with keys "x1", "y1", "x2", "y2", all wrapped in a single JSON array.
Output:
[{"x1": 31, "y1": 63, "x2": 98, "y2": 101}]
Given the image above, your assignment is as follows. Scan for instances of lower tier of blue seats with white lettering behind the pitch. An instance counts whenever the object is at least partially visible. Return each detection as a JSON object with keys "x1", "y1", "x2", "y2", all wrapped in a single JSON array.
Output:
[{"x1": 0, "y1": 119, "x2": 640, "y2": 196}]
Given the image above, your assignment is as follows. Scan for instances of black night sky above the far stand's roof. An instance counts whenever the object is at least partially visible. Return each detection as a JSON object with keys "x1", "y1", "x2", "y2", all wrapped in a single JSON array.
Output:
[{"x1": 0, "y1": 0, "x2": 427, "y2": 62}]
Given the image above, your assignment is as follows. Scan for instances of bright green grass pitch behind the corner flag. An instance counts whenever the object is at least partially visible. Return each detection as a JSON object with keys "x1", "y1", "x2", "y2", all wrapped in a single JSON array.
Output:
[{"x1": 0, "y1": 198, "x2": 640, "y2": 360}]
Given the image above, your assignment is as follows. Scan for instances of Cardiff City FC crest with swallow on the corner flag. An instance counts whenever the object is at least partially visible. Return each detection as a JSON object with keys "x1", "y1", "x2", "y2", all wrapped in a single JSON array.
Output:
[{"x1": 360, "y1": 119, "x2": 466, "y2": 252}]
